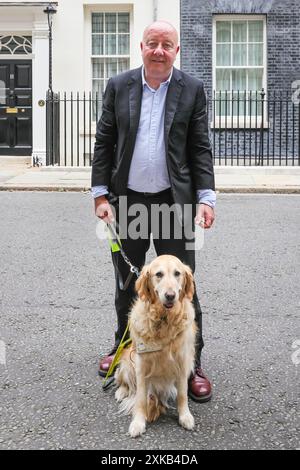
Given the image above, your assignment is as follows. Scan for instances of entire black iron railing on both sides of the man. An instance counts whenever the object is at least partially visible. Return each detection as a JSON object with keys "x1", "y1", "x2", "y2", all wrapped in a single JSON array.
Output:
[{"x1": 46, "y1": 90, "x2": 300, "y2": 166}]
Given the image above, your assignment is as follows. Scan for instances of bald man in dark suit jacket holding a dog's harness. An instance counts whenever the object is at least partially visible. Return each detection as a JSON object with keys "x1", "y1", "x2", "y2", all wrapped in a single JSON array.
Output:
[{"x1": 92, "y1": 21, "x2": 216, "y2": 402}]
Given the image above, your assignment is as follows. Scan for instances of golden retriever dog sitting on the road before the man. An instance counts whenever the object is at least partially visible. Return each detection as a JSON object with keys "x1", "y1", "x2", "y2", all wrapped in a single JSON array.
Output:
[{"x1": 115, "y1": 255, "x2": 196, "y2": 437}]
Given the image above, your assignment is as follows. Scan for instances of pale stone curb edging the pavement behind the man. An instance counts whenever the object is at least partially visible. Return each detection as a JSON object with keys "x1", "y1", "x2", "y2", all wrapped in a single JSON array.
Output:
[{"x1": 0, "y1": 185, "x2": 300, "y2": 194}]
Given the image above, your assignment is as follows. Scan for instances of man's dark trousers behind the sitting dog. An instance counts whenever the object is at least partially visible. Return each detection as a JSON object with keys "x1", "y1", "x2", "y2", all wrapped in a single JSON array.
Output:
[{"x1": 112, "y1": 190, "x2": 204, "y2": 366}]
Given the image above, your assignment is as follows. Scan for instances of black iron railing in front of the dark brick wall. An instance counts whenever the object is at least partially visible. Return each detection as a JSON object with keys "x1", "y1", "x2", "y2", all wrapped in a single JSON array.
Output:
[{"x1": 208, "y1": 90, "x2": 300, "y2": 166}]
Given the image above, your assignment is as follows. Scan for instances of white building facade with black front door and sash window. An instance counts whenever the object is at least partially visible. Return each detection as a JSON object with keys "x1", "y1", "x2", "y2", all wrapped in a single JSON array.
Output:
[{"x1": 0, "y1": 0, "x2": 180, "y2": 164}]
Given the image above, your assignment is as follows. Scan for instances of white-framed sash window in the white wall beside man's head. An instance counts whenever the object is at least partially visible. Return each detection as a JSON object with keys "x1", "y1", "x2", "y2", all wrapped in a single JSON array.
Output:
[{"x1": 92, "y1": 13, "x2": 130, "y2": 101}]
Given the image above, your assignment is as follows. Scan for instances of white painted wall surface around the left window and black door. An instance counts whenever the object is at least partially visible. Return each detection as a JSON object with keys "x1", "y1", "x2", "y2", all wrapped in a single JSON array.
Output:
[{"x1": 0, "y1": 0, "x2": 180, "y2": 164}]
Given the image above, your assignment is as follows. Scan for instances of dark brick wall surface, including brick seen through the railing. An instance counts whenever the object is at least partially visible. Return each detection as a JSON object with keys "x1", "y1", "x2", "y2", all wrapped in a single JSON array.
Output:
[{"x1": 181, "y1": 0, "x2": 300, "y2": 164}]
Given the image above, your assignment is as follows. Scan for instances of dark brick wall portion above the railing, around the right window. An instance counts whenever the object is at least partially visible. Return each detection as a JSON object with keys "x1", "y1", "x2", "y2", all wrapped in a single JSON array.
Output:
[{"x1": 181, "y1": 0, "x2": 300, "y2": 90}]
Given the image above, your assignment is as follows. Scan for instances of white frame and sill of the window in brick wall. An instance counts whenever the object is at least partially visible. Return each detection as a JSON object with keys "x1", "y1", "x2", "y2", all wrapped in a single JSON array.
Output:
[{"x1": 211, "y1": 14, "x2": 268, "y2": 128}]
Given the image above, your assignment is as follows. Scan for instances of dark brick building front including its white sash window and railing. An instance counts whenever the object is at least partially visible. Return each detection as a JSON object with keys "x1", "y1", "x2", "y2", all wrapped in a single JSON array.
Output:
[{"x1": 181, "y1": 0, "x2": 300, "y2": 165}]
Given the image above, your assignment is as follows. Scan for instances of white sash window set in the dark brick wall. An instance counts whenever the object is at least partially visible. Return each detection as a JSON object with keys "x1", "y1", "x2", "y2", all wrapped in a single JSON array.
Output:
[{"x1": 214, "y1": 15, "x2": 266, "y2": 118}]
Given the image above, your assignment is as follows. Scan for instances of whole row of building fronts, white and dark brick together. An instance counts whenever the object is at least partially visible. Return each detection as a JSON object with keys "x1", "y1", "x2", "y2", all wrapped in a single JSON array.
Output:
[{"x1": 0, "y1": 0, "x2": 300, "y2": 166}]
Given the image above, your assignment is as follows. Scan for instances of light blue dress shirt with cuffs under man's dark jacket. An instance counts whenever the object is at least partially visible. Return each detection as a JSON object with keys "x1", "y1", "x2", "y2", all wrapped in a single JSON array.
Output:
[{"x1": 91, "y1": 67, "x2": 216, "y2": 207}]
